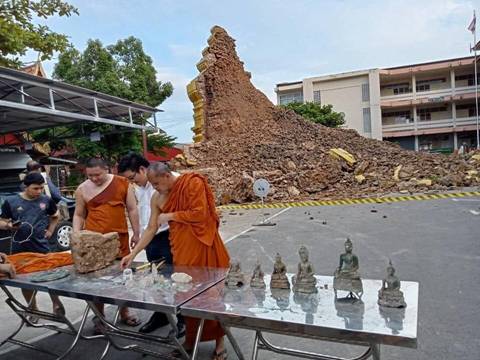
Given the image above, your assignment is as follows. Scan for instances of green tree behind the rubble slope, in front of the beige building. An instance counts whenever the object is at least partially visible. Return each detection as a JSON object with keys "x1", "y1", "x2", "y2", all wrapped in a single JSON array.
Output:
[{"x1": 282, "y1": 102, "x2": 345, "y2": 128}]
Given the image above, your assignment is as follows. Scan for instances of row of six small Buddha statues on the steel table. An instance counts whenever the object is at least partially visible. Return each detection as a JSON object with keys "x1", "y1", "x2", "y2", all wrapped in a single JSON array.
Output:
[{"x1": 225, "y1": 239, "x2": 406, "y2": 308}]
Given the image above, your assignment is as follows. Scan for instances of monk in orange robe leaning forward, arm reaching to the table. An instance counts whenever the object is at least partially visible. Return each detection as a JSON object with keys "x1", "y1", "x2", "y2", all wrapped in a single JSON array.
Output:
[{"x1": 122, "y1": 163, "x2": 230, "y2": 360}]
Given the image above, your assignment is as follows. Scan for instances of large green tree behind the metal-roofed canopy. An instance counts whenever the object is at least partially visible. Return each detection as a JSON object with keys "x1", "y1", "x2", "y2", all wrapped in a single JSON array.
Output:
[{"x1": 53, "y1": 37, "x2": 175, "y2": 159}]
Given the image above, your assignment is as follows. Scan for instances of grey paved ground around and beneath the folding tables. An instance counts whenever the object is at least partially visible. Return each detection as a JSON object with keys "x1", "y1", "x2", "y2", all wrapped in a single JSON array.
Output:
[{"x1": 0, "y1": 197, "x2": 480, "y2": 360}]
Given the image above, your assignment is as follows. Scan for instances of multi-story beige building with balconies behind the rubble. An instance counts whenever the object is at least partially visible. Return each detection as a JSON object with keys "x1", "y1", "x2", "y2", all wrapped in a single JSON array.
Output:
[{"x1": 275, "y1": 57, "x2": 480, "y2": 151}]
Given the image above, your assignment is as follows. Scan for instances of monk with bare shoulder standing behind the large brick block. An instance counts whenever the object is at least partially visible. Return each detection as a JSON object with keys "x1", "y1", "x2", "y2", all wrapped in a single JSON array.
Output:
[{"x1": 73, "y1": 158, "x2": 140, "y2": 326}]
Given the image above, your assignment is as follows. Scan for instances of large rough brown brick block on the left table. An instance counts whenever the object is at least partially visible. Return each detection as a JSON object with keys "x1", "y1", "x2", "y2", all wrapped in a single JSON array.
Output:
[{"x1": 70, "y1": 230, "x2": 120, "y2": 273}]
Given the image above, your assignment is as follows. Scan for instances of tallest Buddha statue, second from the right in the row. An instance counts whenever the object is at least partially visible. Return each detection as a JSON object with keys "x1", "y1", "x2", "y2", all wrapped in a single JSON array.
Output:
[{"x1": 333, "y1": 238, "x2": 363, "y2": 299}]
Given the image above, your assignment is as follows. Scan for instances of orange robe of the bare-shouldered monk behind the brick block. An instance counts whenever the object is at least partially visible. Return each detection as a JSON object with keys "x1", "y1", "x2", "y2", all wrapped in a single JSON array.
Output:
[{"x1": 85, "y1": 175, "x2": 130, "y2": 257}]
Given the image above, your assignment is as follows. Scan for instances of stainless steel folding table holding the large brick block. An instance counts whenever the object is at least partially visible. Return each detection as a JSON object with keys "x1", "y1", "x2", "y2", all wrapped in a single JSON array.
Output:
[{"x1": 0, "y1": 264, "x2": 226, "y2": 359}]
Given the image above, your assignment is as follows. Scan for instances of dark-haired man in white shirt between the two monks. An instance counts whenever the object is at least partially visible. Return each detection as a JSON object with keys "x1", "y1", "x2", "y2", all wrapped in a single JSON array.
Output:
[{"x1": 118, "y1": 153, "x2": 184, "y2": 335}]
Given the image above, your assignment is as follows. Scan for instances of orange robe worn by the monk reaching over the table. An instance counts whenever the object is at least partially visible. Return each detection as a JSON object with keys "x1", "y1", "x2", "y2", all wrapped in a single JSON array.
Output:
[{"x1": 162, "y1": 173, "x2": 230, "y2": 345}]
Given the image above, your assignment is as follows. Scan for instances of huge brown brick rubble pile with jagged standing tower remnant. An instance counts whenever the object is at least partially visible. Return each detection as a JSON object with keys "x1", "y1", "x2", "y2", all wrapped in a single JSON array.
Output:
[{"x1": 181, "y1": 26, "x2": 480, "y2": 204}]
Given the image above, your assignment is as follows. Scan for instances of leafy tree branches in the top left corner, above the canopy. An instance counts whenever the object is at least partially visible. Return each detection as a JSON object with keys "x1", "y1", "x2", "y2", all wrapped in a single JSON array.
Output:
[{"x1": 0, "y1": 0, "x2": 78, "y2": 68}]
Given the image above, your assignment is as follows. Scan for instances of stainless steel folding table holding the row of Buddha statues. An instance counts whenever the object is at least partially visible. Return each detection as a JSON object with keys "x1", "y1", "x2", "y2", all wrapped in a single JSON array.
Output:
[{"x1": 181, "y1": 274, "x2": 418, "y2": 360}]
